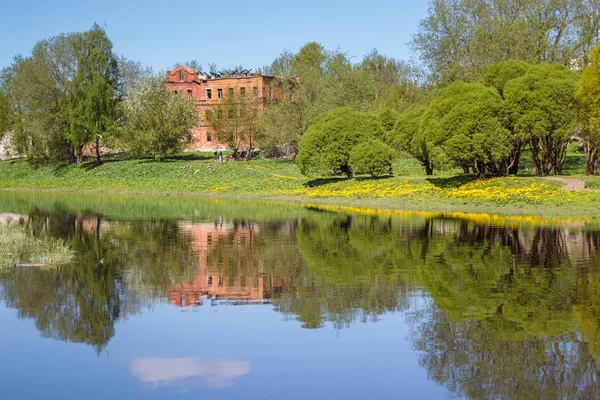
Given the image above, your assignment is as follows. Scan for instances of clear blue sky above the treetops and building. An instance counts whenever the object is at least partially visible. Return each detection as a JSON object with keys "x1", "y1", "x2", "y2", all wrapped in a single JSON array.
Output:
[{"x1": 0, "y1": 0, "x2": 428, "y2": 71}]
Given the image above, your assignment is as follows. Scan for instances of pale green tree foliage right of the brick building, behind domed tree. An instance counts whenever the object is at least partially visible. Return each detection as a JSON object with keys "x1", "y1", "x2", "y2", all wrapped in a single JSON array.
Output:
[{"x1": 261, "y1": 42, "x2": 425, "y2": 156}]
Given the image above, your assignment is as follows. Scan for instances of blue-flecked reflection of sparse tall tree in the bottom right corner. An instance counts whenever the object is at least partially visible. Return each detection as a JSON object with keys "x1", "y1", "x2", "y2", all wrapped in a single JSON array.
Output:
[{"x1": 408, "y1": 304, "x2": 600, "y2": 399}]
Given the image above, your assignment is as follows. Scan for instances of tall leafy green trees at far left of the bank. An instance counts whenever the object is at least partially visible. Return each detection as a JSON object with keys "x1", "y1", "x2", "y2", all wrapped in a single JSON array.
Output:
[{"x1": 2, "y1": 25, "x2": 119, "y2": 164}]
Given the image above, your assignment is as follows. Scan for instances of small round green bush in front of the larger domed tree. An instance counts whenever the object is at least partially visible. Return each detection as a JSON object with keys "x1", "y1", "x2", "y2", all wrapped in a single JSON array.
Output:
[{"x1": 349, "y1": 139, "x2": 395, "y2": 176}]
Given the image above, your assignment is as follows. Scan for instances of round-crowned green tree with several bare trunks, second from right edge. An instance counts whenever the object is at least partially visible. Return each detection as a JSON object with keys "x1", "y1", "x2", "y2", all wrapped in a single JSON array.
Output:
[{"x1": 503, "y1": 64, "x2": 578, "y2": 175}]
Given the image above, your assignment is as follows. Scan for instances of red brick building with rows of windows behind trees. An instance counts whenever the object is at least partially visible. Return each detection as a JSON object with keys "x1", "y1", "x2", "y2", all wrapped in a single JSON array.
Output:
[{"x1": 166, "y1": 65, "x2": 282, "y2": 151}]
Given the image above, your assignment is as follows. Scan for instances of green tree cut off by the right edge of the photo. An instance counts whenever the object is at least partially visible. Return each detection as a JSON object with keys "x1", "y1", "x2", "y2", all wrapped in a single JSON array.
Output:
[{"x1": 575, "y1": 45, "x2": 600, "y2": 175}]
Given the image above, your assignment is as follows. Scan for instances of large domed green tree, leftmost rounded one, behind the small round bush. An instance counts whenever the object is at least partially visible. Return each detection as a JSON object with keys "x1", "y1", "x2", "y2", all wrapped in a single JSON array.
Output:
[{"x1": 296, "y1": 107, "x2": 383, "y2": 178}]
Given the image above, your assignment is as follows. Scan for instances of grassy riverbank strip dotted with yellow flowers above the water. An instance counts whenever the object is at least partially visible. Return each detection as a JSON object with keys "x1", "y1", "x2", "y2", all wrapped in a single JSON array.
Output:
[{"x1": 0, "y1": 159, "x2": 600, "y2": 218}]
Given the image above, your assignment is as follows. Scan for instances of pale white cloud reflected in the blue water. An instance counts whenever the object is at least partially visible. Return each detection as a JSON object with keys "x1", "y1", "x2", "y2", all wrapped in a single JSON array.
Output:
[{"x1": 130, "y1": 357, "x2": 250, "y2": 387}]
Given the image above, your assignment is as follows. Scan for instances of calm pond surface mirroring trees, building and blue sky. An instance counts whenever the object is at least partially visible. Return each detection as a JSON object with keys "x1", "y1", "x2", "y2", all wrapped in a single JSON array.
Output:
[{"x1": 0, "y1": 192, "x2": 600, "y2": 399}]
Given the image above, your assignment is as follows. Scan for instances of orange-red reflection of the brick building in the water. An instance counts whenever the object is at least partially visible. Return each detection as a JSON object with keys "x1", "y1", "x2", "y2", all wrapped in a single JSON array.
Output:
[{"x1": 168, "y1": 222, "x2": 286, "y2": 307}]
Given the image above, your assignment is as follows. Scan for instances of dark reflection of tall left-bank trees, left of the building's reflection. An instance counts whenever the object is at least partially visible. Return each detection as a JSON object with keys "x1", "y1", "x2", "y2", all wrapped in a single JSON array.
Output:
[{"x1": 0, "y1": 212, "x2": 200, "y2": 352}]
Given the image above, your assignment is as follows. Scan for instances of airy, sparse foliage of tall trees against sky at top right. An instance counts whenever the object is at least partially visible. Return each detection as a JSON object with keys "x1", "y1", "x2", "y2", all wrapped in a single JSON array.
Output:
[{"x1": 412, "y1": 0, "x2": 600, "y2": 85}]
